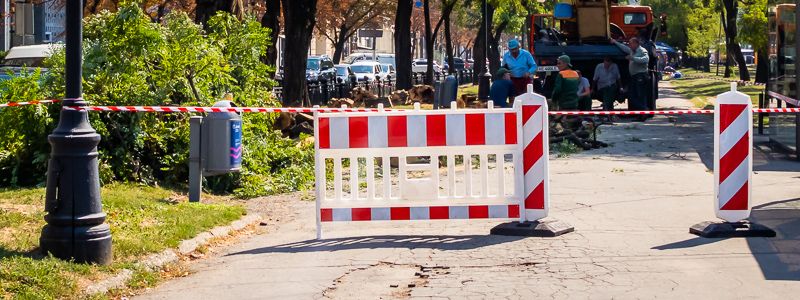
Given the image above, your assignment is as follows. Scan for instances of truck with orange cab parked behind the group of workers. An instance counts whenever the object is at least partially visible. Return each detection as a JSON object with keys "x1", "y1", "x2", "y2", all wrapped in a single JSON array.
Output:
[{"x1": 528, "y1": 0, "x2": 666, "y2": 107}]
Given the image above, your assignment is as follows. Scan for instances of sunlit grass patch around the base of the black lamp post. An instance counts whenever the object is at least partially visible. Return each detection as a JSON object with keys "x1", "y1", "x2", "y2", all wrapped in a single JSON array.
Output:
[{"x1": 0, "y1": 184, "x2": 245, "y2": 299}]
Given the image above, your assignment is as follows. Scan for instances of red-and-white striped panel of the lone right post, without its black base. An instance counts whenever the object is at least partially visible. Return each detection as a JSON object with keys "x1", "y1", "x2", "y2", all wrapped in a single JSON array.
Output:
[{"x1": 714, "y1": 83, "x2": 753, "y2": 222}]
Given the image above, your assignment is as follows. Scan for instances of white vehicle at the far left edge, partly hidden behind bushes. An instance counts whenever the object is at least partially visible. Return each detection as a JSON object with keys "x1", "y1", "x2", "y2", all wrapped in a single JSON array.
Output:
[{"x1": 0, "y1": 44, "x2": 64, "y2": 80}]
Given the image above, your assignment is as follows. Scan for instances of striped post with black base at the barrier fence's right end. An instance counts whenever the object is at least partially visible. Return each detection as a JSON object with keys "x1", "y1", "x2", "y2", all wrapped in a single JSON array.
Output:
[{"x1": 491, "y1": 84, "x2": 575, "y2": 237}]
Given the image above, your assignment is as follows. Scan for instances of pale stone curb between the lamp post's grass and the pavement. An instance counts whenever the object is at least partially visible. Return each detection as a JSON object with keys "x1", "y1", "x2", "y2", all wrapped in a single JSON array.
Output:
[{"x1": 84, "y1": 214, "x2": 261, "y2": 295}]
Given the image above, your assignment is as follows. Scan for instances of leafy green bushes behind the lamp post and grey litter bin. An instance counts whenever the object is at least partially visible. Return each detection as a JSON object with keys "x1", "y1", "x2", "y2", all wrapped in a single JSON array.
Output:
[{"x1": 0, "y1": 3, "x2": 313, "y2": 197}]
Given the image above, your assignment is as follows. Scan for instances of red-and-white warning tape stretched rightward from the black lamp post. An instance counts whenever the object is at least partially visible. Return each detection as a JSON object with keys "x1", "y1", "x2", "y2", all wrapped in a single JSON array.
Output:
[{"x1": 64, "y1": 106, "x2": 800, "y2": 116}]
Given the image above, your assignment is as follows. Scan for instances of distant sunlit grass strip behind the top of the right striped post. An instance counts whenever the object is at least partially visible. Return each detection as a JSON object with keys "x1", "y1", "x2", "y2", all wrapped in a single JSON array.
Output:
[{"x1": 670, "y1": 69, "x2": 764, "y2": 109}]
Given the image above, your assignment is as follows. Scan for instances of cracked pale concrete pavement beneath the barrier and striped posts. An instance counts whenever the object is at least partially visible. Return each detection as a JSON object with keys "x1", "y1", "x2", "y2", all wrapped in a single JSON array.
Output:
[{"x1": 139, "y1": 83, "x2": 800, "y2": 299}]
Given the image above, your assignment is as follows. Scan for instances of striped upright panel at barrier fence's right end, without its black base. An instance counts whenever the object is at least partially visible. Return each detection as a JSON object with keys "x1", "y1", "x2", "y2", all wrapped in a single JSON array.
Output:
[{"x1": 516, "y1": 85, "x2": 550, "y2": 221}]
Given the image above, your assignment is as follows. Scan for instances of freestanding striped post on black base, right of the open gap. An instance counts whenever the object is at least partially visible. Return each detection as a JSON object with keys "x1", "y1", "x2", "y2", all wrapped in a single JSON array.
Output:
[{"x1": 689, "y1": 82, "x2": 775, "y2": 237}]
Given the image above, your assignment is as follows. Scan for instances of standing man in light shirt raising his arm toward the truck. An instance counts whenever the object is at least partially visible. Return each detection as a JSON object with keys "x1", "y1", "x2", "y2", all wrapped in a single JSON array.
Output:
[{"x1": 611, "y1": 37, "x2": 650, "y2": 116}]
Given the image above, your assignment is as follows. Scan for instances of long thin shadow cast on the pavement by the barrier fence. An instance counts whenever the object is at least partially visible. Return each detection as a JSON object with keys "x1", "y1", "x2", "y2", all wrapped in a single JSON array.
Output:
[{"x1": 229, "y1": 235, "x2": 524, "y2": 255}]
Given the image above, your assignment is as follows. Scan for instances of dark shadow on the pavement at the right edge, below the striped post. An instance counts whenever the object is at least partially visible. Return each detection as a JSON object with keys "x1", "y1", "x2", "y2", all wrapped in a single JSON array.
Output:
[{"x1": 747, "y1": 198, "x2": 800, "y2": 281}]
